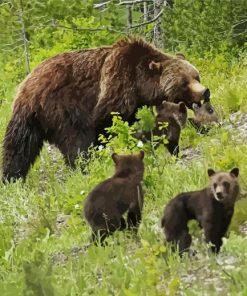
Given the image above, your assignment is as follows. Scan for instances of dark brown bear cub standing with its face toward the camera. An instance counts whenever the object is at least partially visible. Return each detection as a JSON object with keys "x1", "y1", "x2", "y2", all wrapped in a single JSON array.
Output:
[{"x1": 161, "y1": 168, "x2": 239, "y2": 253}]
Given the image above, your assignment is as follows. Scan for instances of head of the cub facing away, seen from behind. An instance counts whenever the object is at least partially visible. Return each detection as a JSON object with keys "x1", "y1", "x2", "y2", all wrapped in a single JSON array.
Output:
[{"x1": 112, "y1": 151, "x2": 144, "y2": 183}]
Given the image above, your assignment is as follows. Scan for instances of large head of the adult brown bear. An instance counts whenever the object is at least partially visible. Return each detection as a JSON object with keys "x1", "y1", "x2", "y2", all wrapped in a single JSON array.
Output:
[{"x1": 149, "y1": 54, "x2": 210, "y2": 109}]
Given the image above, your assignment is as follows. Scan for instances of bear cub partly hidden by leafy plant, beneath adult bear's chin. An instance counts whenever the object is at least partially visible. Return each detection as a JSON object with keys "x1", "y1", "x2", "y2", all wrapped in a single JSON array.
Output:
[{"x1": 134, "y1": 101, "x2": 187, "y2": 157}]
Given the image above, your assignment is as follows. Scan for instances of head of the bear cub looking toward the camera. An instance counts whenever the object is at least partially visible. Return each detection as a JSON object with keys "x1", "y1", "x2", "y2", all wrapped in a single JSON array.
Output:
[{"x1": 208, "y1": 168, "x2": 239, "y2": 206}]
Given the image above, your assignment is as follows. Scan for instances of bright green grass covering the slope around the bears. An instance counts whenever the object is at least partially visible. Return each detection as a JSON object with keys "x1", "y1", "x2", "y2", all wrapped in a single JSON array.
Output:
[{"x1": 0, "y1": 55, "x2": 247, "y2": 296}]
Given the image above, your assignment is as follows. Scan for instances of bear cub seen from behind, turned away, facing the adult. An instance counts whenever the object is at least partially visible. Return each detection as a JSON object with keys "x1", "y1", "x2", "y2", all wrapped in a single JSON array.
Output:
[{"x1": 84, "y1": 151, "x2": 144, "y2": 244}]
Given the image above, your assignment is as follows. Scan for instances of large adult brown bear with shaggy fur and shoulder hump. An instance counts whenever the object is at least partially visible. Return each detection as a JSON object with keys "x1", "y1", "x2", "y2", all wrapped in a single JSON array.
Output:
[{"x1": 3, "y1": 38, "x2": 209, "y2": 181}]
